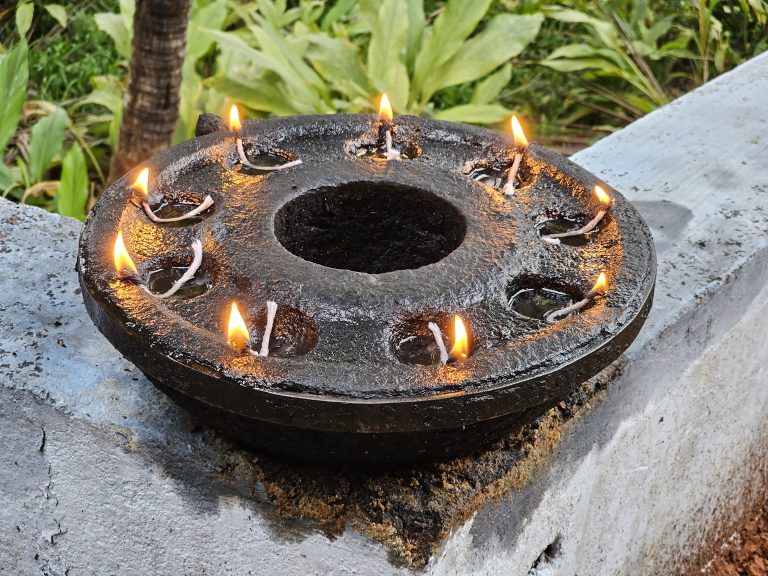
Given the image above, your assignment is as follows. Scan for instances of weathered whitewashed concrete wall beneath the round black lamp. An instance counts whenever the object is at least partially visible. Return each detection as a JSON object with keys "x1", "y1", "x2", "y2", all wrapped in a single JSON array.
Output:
[{"x1": 0, "y1": 55, "x2": 768, "y2": 576}]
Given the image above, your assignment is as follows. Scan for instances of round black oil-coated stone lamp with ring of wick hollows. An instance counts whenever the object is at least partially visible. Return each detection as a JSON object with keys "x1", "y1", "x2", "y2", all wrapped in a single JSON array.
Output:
[{"x1": 78, "y1": 115, "x2": 656, "y2": 465}]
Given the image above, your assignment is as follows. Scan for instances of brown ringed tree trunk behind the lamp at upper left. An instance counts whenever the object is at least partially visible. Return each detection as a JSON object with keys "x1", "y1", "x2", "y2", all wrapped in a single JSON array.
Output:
[{"x1": 109, "y1": 0, "x2": 192, "y2": 182}]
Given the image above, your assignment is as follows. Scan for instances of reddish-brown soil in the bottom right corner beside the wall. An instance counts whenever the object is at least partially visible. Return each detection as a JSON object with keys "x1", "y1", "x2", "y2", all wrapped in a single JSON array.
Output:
[{"x1": 691, "y1": 499, "x2": 768, "y2": 576}]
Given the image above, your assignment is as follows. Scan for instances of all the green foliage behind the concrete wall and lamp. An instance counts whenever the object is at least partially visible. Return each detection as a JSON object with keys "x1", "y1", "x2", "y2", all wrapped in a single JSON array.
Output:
[{"x1": 0, "y1": 0, "x2": 768, "y2": 219}]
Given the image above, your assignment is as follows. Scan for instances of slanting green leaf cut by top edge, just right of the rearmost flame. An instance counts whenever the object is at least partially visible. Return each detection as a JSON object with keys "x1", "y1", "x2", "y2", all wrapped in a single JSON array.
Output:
[{"x1": 413, "y1": 0, "x2": 491, "y2": 104}]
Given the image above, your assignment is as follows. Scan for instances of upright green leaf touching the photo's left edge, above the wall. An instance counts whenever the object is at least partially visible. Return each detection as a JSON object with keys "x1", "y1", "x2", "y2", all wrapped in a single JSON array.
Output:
[{"x1": 0, "y1": 40, "x2": 29, "y2": 157}]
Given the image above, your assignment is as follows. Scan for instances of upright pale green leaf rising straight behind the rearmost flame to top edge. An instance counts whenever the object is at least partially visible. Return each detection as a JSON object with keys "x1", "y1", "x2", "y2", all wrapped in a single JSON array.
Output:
[{"x1": 368, "y1": 0, "x2": 408, "y2": 110}]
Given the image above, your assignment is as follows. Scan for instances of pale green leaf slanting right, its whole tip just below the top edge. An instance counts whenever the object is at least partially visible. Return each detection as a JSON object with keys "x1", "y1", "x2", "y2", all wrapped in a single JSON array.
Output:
[{"x1": 437, "y1": 14, "x2": 544, "y2": 89}]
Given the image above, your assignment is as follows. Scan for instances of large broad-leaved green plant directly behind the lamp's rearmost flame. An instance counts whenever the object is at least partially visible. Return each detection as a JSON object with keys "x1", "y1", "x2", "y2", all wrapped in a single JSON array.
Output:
[{"x1": 204, "y1": 0, "x2": 543, "y2": 124}]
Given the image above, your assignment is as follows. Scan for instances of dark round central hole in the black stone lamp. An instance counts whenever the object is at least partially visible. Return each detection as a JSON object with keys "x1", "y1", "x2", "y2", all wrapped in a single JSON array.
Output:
[{"x1": 275, "y1": 182, "x2": 467, "y2": 274}]
